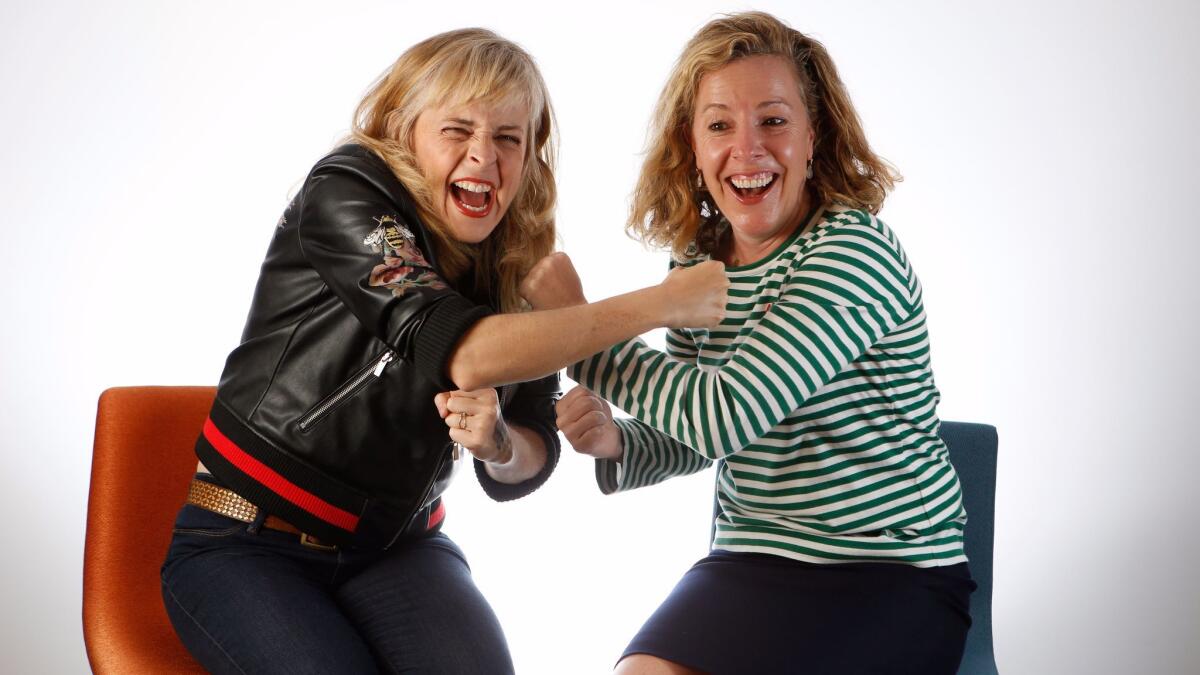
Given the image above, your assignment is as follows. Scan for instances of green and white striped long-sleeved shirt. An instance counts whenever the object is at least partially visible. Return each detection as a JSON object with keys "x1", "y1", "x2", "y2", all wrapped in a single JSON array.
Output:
[{"x1": 570, "y1": 207, "x2": 966, "y2": 567}]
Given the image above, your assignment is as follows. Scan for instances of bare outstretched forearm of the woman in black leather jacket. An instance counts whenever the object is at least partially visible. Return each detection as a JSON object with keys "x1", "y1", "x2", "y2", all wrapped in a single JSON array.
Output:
[{"x1": 446, "y1": 286, "x2": 670, "y2": 389}]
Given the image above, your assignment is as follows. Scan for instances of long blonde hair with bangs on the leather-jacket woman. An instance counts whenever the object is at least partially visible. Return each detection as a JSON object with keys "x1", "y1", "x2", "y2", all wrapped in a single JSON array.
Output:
[{"x1": 349, "y1": 28, "x2": 557, "y2": 311}]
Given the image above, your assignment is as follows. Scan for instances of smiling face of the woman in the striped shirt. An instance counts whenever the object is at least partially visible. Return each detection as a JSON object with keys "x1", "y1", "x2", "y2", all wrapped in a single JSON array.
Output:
[{"x1": 691, "y1": 56, "x2": 814, "y2": 246}]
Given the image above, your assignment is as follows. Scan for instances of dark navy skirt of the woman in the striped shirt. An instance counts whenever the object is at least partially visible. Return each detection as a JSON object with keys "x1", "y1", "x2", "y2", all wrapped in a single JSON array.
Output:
[{"x1": 625, "y1": 551, "x2": 976, "y2": 675}]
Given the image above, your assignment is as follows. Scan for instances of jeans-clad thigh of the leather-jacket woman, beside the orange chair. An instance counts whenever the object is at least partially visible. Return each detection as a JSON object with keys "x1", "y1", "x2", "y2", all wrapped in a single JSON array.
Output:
[{"x1": 162, "y1": 506, "x2": 378, "y2": 675}]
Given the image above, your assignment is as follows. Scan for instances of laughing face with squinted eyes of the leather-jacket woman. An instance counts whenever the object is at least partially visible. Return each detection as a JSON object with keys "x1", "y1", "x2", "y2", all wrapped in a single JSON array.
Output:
[{"x1": 413, "y1": 94, "x2": 529, "y2": 244}]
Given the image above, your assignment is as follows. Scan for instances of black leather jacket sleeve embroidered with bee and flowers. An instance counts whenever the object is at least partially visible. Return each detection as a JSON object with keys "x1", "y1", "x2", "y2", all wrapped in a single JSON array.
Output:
[{"x1": 296, "y1": 157, "x2": 491, "y2": 390}]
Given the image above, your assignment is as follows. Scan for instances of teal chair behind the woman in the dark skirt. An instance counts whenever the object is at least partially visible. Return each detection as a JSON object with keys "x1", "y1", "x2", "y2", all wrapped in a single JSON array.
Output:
[{"x1": 708, "y1": 422, "x2": 1000, "y2": 675}]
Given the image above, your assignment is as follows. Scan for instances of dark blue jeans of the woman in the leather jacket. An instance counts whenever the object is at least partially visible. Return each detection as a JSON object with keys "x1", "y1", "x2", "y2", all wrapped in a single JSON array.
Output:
[{"x1": 162, "y1": 504, "x2": 512, "y2": 675}]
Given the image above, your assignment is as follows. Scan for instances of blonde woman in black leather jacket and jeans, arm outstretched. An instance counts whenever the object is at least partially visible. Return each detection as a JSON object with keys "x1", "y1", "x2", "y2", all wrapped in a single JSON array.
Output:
[{"x1": 162, "y1": 29, "x2": 727, "y2": 675}]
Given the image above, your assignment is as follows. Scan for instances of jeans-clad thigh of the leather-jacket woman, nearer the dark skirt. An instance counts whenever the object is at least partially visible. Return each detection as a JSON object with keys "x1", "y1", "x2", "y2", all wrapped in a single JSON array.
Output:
[{"x1": 337, "y1": 534, "x2": 512, "y2": 675}]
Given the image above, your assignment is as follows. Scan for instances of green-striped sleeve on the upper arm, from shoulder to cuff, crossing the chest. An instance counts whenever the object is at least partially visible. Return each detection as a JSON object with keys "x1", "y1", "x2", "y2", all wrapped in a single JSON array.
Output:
[{"x1": 570, "y1": 223, "x2": 914, "y2": 460}]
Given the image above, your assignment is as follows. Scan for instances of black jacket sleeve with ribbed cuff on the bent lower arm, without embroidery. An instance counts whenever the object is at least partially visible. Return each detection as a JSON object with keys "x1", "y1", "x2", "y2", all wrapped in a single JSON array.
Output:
[{"x1": 475, "y1": 372, "x2": 560, "y2": 502}]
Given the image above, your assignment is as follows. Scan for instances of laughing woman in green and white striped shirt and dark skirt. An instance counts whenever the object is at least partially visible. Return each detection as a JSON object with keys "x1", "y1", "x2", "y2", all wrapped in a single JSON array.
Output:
[{"x1": 528, "y1": 13, "x2": 974, "y2": 674}]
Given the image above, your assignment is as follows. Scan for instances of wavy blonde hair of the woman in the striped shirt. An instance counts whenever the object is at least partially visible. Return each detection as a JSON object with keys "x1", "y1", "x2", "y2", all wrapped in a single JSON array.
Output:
[{"x1": 626, "y1": 12, "x2": 900, "y2": 257}]
